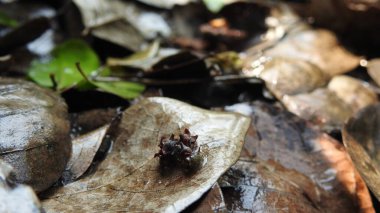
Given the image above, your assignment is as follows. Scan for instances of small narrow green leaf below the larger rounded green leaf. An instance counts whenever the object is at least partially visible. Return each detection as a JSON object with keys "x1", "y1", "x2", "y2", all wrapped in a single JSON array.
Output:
[{"x1": 90, "y1": 81, "x2": 145, "y2": 99}]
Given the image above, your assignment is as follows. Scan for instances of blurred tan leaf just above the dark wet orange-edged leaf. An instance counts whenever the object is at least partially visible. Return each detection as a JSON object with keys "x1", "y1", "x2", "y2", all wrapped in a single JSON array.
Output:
[{"x1": 282, "y1": 75, "x2": 378, "y2": 131}]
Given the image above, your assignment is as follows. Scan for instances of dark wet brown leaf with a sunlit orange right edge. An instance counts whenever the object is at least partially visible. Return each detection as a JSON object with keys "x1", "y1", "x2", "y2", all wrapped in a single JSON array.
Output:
[{"x1": 226, "y1": 102, "x2": 374, "y2": 212}]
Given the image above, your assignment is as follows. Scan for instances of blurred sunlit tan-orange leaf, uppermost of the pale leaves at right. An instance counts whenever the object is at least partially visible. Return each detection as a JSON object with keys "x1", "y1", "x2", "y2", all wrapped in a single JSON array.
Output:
[{"x1": 246, "y1": 24, "x2": 360, "y2": 76}]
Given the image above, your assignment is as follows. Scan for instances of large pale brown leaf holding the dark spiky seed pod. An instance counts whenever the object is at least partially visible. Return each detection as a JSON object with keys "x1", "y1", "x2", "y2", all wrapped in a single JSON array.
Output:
[{"x1": 43, "y1": 98, "x2": 249, "y2": 212}]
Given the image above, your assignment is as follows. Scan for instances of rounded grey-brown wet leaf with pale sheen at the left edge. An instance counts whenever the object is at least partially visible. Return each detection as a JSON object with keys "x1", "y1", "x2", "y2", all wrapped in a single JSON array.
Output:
[{"x1": 0, "y1": 78, "x2": 71, "y2": 192}]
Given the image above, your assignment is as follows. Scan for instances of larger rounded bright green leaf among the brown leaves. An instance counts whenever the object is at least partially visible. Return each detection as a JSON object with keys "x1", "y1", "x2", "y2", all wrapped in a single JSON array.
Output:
[{"x1": 28, "y1": 39, "x2": 100, "y2": 91}]
